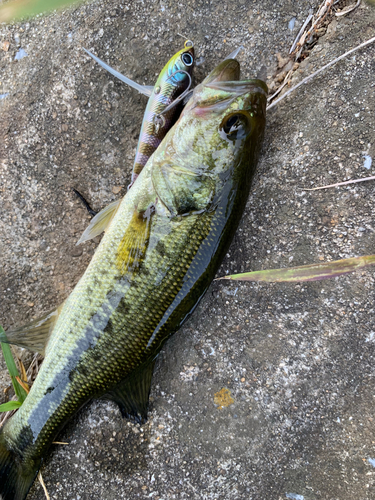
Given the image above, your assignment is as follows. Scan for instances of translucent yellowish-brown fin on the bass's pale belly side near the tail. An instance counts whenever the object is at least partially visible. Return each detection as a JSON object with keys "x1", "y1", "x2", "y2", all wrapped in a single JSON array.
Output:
[{"x1": 0, "y1": 302, "x2": 64, "y2": 356}]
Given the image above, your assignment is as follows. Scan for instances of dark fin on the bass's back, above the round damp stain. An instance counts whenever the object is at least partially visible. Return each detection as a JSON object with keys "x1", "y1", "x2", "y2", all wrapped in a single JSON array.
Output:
[{"x1": 103, "y1": 360, "x2": 155, "y2": 423}]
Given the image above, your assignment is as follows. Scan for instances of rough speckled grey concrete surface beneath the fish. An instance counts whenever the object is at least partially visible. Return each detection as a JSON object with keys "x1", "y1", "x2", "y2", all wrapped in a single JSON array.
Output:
[{"x1": 0, "y1": 0, "x2": 375, "y2": 500}]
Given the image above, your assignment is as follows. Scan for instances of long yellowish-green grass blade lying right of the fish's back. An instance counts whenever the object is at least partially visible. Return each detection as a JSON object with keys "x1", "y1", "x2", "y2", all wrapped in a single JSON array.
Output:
[{"x1": 218, "y1": 255, "x2": 375, "y2": 282}]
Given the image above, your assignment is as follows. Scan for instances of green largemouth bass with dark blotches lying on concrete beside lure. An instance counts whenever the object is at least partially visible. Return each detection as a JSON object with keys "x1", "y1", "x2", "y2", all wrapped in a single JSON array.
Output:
[{"x1": 0, "y1": 60, "x2": 267, "y2": 500}]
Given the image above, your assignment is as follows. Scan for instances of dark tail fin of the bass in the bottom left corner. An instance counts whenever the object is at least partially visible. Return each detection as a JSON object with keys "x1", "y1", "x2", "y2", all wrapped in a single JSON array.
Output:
[{"x1": 0, "y1": 429, "x2": 39, "y2": 500}]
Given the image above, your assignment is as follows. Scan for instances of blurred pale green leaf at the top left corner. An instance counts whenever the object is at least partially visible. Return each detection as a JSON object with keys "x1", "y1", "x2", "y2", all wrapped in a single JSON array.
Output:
[{"x1": 0, "y1": 0, "x2": 86, "y2": 23}]
